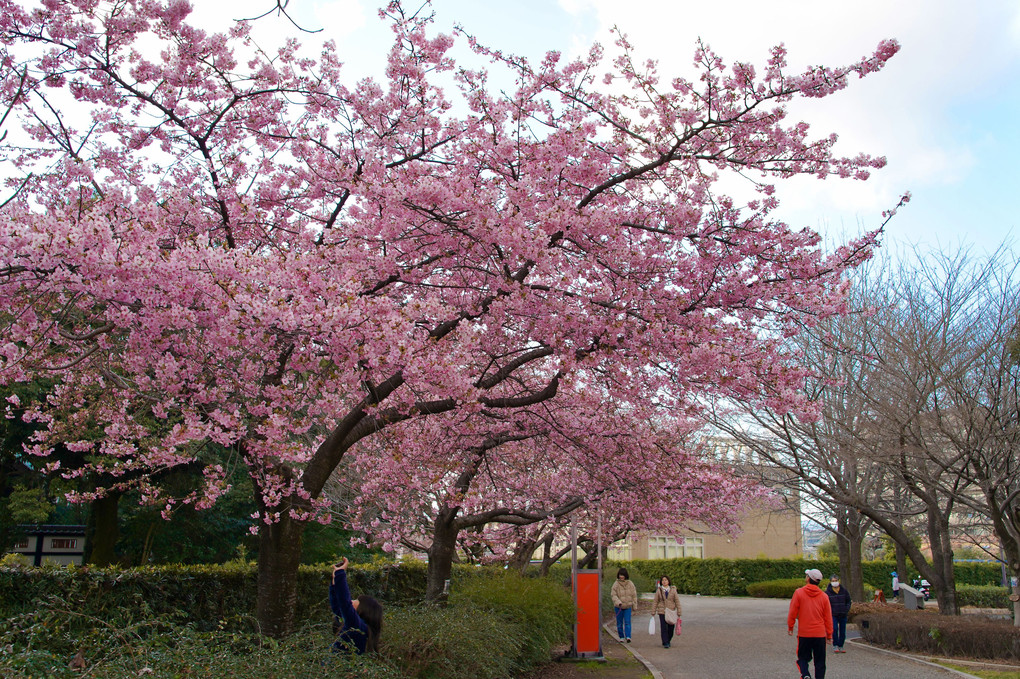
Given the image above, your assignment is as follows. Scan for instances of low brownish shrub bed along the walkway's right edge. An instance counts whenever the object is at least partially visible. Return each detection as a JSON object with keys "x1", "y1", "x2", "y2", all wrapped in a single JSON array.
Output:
[{"x1": 852, "y1": 605, "x2": 1020, "y2": 660}]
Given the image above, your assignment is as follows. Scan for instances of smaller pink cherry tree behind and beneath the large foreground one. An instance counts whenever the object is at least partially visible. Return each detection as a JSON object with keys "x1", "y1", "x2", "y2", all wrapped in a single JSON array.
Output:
[{"x1": 344, "y1": 384, "x2": 768, "y2": 599}]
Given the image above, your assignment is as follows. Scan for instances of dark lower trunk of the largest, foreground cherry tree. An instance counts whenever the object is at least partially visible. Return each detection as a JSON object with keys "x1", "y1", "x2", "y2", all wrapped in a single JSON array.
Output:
[{"x1": 256, "y1": 512, "x2": 305, "y2": 639}]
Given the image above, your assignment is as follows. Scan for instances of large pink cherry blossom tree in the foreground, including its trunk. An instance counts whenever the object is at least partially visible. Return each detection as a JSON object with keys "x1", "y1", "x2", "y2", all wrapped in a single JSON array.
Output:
[{"x1": 0, "y1": 0, "x2": 898, "y2": 636}]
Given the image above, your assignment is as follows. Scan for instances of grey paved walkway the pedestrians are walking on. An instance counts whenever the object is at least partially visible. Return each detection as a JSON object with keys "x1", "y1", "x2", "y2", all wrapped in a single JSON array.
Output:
[{"x1": 607, "y1": 596, "x2": 970, "y2": 679}]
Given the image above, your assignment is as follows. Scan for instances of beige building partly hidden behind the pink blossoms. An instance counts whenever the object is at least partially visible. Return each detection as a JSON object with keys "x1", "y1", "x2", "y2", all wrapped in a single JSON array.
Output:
[{"x1": 609, "y1": 439, "x2": 804, "y2": 561}]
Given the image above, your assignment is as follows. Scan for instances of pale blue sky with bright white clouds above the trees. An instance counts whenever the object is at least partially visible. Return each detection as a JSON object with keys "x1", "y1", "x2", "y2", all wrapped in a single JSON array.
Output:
[{"x1": 193, "y1": 0, "x2": 1020, "y2": 254}]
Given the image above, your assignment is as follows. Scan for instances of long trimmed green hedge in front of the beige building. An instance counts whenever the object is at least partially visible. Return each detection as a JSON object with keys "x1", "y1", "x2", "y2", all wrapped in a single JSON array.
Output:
[{"x1": 607, "y1": 559, "x2": 1002, "y2": 596}]
